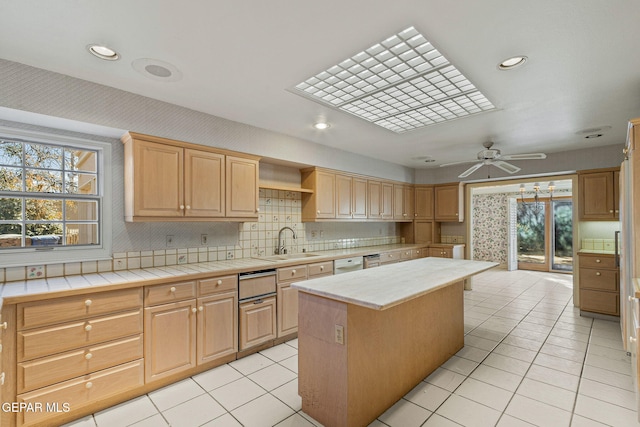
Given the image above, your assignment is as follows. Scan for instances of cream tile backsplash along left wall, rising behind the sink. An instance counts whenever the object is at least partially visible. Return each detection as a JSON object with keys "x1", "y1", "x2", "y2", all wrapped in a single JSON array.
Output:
[{"x1": 0, "y1": 189, "x2": 400, "y2": 283}]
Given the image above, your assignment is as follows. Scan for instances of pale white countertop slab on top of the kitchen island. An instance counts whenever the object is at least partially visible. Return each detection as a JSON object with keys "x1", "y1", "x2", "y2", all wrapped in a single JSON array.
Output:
[{"x1": 291, "y1": 258, "x2": 498, "y2": 310}]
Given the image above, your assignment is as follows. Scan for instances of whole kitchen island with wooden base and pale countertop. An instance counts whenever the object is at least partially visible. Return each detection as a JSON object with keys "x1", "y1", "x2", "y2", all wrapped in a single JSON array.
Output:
[{"x1": 292, "y1": 258, "x2": 497, "y2": 427}]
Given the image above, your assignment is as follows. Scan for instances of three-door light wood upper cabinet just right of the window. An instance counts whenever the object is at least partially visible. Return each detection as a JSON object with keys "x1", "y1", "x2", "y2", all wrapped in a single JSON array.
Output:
[{"x1": 122, "y1": 132, "x2": 259, "y2": 221}]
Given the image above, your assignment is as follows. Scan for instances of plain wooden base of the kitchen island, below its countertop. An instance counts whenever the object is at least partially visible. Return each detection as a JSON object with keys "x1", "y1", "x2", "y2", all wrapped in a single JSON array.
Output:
[{"x1": 298, "y1": 281, "x2": 464, "y2": 427}]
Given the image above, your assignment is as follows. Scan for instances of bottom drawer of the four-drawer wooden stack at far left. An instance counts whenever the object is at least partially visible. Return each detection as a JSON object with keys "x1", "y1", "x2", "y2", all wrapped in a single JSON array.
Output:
[{"x1": 18, "y1": 359, "x2": 144, "y2": 425}]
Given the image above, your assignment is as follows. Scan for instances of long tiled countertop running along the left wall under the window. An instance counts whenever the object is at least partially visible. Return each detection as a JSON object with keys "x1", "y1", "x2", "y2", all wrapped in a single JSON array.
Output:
[{"x1": 0, "y1": 244, "x2": 456, "y2": 308}]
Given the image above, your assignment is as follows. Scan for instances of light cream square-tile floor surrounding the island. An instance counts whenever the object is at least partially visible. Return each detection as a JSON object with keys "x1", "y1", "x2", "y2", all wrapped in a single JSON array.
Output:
[{"x1": 61, "y1": 270, "x2": 640, "y2": 427}]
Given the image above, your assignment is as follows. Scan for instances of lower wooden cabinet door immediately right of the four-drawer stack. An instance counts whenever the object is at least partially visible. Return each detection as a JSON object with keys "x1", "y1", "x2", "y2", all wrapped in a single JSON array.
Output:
[{"x1": 144, "y1": 300, "x2": 197, "y2": 382}]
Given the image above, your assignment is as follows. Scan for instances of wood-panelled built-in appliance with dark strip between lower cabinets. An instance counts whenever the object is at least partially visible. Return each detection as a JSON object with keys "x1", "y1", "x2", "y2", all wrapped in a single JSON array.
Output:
[{"x1": 238, "y1": 269, "x2": 277, "y2": 351}]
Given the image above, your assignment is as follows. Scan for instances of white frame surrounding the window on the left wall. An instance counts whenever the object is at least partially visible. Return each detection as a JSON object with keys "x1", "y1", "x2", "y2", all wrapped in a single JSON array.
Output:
[{"x1": 0, "y1": 126, "x2": 112, "y2": 268}]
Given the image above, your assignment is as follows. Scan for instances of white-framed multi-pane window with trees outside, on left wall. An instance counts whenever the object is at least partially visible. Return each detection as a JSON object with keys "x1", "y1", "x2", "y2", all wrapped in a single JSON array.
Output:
[{"x1": 0, "y1": 129, "x2": 110, "y2": 266}]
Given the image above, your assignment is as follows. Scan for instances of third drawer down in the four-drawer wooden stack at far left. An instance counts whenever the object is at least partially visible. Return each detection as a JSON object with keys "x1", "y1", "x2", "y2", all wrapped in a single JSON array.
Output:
[{"x1": 17, "y1": 334, "x2": 142, "y2": 393}]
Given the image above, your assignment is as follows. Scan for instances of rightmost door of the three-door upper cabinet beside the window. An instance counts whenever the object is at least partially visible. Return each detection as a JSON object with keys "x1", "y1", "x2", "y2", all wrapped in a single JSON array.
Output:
[{"x1": 225, "y1": 156, "x2": 259, "y2": 218}]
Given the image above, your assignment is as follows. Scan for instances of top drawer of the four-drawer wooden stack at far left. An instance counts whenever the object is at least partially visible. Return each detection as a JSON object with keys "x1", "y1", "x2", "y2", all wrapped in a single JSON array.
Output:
[{"x1": 18, "y1": 288, "x2": 142, "y2": 330}]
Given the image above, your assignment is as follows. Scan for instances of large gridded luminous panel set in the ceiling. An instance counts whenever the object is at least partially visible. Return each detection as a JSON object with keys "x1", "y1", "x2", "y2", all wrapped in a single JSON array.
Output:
[{"x1": 295, "y1": 27, "x2": 495, "y2": 133}]
